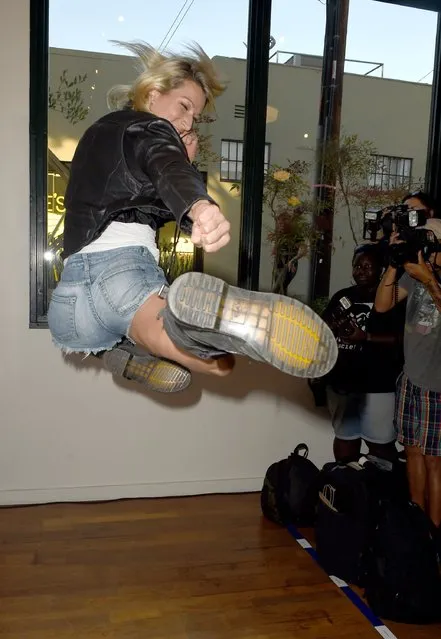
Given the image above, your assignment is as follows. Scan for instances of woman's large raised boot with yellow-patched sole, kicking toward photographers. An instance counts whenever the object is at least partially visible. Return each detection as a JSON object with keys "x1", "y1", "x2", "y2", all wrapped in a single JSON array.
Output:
[{"x1": 164, "y1": 272, "x2": 338, "y2": 379}]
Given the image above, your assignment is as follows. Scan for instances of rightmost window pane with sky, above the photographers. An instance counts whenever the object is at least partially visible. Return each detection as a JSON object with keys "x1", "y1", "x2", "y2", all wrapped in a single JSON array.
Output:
[{"x1": 328, "y1": 0, "x2": 437, "y2": 294}]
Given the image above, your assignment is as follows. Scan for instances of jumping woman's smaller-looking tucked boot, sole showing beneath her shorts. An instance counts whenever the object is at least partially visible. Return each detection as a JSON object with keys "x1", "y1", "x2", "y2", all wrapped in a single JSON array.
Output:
[{"x1": 99, "y1": 340, "x2": 191, "y2": 393}]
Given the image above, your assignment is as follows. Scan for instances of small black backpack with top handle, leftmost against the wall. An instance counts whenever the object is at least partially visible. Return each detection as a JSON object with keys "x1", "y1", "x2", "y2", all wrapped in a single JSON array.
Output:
[{"x1": 260, "y1": 444, "x2": 320, "y2": 526}]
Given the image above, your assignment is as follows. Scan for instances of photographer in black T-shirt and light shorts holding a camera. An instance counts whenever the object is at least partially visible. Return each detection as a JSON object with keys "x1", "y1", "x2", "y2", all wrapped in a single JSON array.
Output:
[{"x1": 322, "y1": 244, "x2": 404, "y2": 461}]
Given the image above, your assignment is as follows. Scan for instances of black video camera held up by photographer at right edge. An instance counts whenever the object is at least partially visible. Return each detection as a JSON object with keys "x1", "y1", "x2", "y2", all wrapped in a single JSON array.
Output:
[{"x1": 363, "y1": 204, "x2": 439, "y2": 267}]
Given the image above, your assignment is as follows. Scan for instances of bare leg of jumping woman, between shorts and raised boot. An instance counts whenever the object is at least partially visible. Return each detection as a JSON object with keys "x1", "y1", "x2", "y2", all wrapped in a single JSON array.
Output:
[{"x1": 130, "y1": 295, "x2": 234, "y2": 377}]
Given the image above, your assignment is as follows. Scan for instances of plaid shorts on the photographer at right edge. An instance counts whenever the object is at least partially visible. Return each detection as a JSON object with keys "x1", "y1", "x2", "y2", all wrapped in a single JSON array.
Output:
[{"x1": 394, "y1": 373, "x2": 441, "y2": 457}]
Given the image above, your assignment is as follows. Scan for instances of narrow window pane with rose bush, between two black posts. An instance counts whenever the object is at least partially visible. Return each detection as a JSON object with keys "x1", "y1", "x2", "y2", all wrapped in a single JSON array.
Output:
[{"x1": 260, "y1": 0, "x2": 326, "y2": 299}]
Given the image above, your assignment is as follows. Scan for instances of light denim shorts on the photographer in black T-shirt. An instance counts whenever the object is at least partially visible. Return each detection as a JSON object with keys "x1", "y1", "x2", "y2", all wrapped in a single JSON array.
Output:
[{"x1": 327, "y1": 386, "x2": 395, "y2": 444}]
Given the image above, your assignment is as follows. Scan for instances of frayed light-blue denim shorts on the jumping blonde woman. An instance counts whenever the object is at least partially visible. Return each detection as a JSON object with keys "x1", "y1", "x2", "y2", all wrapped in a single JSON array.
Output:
[{"x1": 48, "y1": 246, "x2": 167, "y2": 353}]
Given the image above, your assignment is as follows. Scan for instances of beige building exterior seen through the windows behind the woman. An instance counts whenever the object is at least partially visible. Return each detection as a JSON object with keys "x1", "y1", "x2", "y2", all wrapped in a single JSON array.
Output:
[{"x1": 49, "y1": 49, "x2": 431, "y2": 298}]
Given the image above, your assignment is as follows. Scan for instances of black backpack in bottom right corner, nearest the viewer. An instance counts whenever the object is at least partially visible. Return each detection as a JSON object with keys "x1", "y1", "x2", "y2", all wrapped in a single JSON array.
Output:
[{"x1": 363, "y1": 501, "x2": 441, "y2": 624}]
